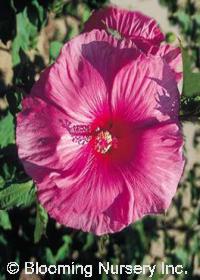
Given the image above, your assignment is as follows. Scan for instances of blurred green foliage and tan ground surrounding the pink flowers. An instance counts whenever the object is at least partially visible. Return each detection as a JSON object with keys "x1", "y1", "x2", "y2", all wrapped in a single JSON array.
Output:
[{"x1": 0, "y1": 0, "x2": 200, "y2": 280}]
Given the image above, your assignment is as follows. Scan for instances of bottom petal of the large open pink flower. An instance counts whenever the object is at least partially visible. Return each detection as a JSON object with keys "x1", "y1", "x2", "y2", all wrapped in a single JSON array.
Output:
[{"x1": 38, "y1": 159, "x2": 134, "y2": 235}]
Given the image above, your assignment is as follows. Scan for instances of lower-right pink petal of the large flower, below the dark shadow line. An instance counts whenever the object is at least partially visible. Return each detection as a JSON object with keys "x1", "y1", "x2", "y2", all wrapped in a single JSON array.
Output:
[{"x1": 126, "y1": 123, "x2": 184, "y2": 221}]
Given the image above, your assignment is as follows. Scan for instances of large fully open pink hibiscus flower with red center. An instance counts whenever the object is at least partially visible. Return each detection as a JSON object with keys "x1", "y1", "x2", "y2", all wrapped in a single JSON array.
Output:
[{"x1": 17, "y1": 9, "x2": 184, "y2": 235}]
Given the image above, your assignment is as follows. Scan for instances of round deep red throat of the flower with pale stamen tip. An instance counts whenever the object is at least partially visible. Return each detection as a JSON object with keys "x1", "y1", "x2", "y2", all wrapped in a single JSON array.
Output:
[{"x1": 89, "y1": 116, "x2": 139, "y2": 164}]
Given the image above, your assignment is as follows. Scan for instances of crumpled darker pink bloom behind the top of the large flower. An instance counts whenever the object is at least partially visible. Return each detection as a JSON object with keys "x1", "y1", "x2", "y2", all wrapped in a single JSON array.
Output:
[{"x1": 85, "y1": 6, "x2": 164, "y2": 47}]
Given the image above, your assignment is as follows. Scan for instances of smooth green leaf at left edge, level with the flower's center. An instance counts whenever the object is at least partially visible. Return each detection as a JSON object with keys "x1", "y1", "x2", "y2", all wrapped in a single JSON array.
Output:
[{"x1": 0, "y1": 113, "x2": 15, "y2": 148}]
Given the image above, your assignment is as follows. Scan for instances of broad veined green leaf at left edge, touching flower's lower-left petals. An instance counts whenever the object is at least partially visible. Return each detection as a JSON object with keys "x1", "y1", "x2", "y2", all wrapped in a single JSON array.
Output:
[{"x1": 0, "y1": 181, "x2": 35, "y2": 210}]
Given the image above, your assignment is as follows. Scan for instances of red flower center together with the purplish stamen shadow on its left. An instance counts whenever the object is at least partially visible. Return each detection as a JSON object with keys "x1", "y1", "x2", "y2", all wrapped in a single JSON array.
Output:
[{"x1": 65, "y1": 117, "x2": 139, "y2": 163}]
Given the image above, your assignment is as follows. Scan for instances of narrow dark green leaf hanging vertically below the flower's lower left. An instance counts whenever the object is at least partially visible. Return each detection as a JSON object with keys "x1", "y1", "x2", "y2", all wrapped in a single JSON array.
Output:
[{"x1": 34, "y1": 204, "x2": 48, "y2": 243}]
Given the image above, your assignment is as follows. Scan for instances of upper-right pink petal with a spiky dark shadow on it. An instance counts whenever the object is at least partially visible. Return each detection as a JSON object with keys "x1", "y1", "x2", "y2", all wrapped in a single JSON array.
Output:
[{"x1": 111, "y1": 55, "x2": 180, "y2": 124}]
